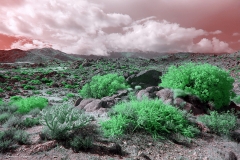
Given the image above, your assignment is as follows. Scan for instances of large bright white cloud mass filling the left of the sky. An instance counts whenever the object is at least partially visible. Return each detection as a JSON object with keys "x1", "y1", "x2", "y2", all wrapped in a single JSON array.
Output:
[{"x1": 0, "y1": 0, "x2": 132, "y2": 54}]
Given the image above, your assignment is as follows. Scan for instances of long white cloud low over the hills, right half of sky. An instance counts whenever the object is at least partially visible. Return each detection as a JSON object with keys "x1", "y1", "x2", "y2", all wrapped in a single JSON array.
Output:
[{"x1": 106, "y1": 20, "x2": 231, "y2": 53}]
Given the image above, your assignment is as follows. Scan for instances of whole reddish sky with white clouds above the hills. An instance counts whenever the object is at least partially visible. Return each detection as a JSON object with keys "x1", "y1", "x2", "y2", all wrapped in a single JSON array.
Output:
[{"x1": 0, "y1": 0, "x2": 240, "y2": 56}]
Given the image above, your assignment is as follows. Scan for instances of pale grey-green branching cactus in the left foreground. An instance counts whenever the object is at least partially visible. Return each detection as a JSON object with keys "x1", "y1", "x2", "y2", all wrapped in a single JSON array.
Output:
[{"x1": 40, "y1": 105, "x2": 90, "y2": 139}]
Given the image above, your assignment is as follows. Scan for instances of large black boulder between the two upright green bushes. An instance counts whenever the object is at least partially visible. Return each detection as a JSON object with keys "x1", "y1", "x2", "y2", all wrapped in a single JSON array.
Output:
[{"x1": 126, "y1": 70, "x2": 162, "y2": 88}]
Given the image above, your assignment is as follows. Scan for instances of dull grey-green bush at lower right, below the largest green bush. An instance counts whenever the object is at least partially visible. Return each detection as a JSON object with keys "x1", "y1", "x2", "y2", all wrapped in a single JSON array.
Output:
[{"x1": 197, "y1": 111, "x2": 237, "y2": 135}]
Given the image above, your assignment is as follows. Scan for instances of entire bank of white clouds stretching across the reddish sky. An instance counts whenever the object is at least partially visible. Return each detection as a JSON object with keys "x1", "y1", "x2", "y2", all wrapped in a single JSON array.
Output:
[{"x1": 0, "y1": 0, "x2": 236, "y2": 55}]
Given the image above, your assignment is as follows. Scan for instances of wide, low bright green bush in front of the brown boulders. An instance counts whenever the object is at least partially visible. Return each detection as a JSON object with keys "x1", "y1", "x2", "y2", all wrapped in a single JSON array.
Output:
[{"x1": 100, "y1": 98, "x2": 199, "y2": 138}]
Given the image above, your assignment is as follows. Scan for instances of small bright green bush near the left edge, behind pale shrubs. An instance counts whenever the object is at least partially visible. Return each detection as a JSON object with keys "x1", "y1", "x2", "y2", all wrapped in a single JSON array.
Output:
[{"x1": 10, "y1": 96, "x2": 48, "y2": 113}]
